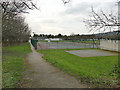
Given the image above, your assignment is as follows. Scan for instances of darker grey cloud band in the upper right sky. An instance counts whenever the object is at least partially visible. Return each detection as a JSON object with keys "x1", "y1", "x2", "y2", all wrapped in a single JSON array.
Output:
[{"x1": 63, "y1": 2, "x2": 115, "y2": 15}]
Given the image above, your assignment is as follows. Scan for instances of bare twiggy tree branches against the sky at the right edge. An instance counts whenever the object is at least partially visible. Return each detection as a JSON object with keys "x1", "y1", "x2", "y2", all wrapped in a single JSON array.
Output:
[{"x1": 84, "y1": 2, "x2": 120, "y2": 32}]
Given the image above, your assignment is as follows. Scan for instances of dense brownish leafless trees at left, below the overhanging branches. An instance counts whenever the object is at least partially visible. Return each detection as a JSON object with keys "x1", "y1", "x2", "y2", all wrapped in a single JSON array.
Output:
[{"x1": 2, "y1": 13, "x2": 30, "y2": 45}]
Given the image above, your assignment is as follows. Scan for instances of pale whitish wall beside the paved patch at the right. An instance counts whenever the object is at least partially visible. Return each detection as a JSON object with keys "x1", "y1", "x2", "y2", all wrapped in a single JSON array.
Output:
[{"x1": 100, "y1": 39, "x2": 120, "y2": 52}]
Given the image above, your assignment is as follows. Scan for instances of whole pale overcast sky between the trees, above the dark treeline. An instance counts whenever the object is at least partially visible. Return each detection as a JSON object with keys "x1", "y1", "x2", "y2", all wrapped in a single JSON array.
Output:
[{"x1": 25, "y1": 0, "x2": 117, "y2": 35}]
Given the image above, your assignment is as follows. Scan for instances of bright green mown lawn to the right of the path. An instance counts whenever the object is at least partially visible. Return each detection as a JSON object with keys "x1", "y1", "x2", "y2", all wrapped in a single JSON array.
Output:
[{"x1": 38, "y1": 49, "x2": 118, "y2": 87}]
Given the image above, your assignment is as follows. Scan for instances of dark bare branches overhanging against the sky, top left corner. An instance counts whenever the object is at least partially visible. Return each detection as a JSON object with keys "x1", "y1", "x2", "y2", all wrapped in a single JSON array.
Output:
[{"x1": 0, "y1": 0, "x2": 38, "y2": 14}]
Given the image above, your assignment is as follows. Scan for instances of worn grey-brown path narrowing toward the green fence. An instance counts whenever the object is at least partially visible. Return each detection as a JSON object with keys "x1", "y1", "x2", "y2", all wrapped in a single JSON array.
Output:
[{"x1": 19, "y1": 43, "x2": 87, "y2": 88}]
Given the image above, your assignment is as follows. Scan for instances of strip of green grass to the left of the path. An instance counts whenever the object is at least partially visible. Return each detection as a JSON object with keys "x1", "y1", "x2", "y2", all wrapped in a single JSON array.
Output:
[{"x1": 2, "y1": 43, "x2": 31, "y2": 88}]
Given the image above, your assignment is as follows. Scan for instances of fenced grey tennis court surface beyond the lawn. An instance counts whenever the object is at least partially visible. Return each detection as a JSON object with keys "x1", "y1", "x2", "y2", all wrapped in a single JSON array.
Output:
[{"x1": 37, "y1": 42, "x2": 99, "y2": 49}]
